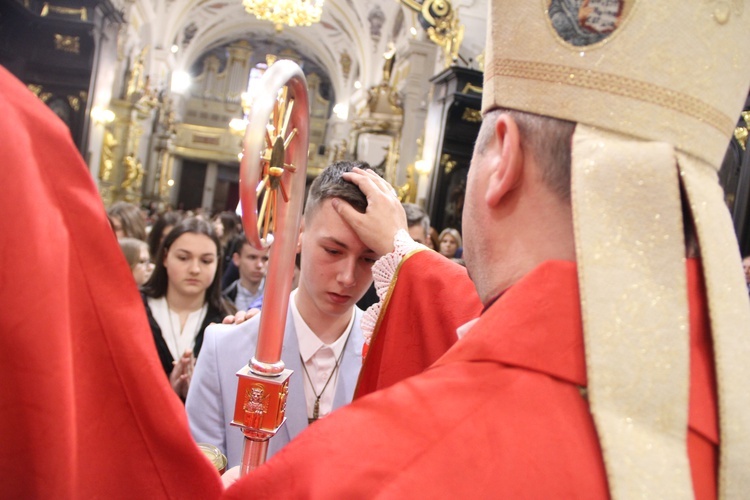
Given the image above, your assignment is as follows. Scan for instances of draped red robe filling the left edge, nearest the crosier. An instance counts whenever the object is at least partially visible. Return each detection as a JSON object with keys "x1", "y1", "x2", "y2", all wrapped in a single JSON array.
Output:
[{"x1": 0, "y1": 67, "x2": 222, "y2": 499}]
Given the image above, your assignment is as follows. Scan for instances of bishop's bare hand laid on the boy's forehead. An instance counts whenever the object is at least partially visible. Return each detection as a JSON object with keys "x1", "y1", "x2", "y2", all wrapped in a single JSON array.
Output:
[{"x1": 332, "y1": 167, "x2": 407, "y2": 257}]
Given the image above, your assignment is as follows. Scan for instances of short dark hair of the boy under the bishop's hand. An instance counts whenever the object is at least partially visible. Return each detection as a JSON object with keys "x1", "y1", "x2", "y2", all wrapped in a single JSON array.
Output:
[{"x1": 305, "y1": 161, "x2": 372, "y2": 220}]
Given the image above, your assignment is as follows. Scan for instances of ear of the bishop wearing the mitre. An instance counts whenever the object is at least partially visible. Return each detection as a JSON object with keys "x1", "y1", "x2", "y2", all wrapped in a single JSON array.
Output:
[{"x1": 486, "y1": 113, "x2": 524, "y2": 206}]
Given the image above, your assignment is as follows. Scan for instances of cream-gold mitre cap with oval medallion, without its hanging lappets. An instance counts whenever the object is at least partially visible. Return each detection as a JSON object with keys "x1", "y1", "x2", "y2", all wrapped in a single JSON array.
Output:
[{"x1": 482, "y1": 0, "x2": 750, "y2": 165}]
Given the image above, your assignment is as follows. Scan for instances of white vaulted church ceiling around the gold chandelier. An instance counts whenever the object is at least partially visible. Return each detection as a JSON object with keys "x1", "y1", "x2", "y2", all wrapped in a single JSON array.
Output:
[{"x1": 133, "y1": 0, "x2": 487, "y2": 105}]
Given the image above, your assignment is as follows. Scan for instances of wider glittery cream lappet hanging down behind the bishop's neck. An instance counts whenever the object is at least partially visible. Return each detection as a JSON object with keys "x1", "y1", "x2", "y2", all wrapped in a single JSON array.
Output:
[{"x1": 571, "y1": 124, "x2": 692, "y2": 498}]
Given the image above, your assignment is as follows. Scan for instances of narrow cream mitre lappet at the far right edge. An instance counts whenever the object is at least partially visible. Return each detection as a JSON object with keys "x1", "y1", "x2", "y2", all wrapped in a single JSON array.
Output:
[{"x1": 677, "y1": 152, "x2": 750, "y2": 498}]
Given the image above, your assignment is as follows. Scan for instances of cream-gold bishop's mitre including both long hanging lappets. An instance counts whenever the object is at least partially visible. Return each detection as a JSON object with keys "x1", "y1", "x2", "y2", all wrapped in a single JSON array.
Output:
[{"x1": 482, "y1": 0, "x2": 750, "y2": 498}]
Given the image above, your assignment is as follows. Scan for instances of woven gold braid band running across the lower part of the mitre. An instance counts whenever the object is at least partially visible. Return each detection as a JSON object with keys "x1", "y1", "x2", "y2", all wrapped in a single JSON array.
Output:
[{"x1": 485, "y1": 59, "x2": 735, "y2": 134}]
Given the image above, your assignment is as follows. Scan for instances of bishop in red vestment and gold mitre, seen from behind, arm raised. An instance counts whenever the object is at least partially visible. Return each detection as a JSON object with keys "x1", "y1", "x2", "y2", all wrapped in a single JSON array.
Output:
[{"x1": 225, "y1": 0, "x2": 750, "y2": 499}]
